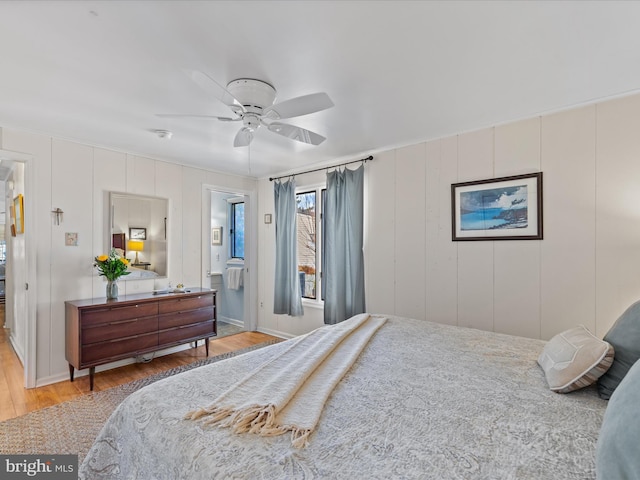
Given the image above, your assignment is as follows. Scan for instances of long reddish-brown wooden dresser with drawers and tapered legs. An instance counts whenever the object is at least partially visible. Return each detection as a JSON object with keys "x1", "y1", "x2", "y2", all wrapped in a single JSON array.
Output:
[{"x1": 65, "y1": 288, "x2": 217, "y2": 390}]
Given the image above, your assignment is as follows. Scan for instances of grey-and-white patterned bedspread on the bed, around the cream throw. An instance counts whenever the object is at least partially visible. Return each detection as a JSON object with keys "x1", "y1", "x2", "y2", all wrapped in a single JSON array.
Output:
[{"x1": 80, "y1": 316, "x2": 607, "y2": 480}]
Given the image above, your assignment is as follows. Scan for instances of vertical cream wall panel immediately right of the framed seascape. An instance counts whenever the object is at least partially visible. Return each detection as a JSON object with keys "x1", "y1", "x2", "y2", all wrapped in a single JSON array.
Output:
[{"x1": 540, "y1": 106, "x2": 596, "y2": 338}]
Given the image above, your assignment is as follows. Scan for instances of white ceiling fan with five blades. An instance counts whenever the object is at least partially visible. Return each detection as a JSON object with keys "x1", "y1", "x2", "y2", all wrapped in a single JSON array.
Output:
[{"x1": 157, "y1": 70, "x2": 333, "y2": 147}]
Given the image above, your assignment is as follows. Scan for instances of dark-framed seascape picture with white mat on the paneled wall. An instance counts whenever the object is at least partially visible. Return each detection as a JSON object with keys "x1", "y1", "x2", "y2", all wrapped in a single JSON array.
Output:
[{"x1": 451, "y1": 172, "x2": 543, "y2": 241}]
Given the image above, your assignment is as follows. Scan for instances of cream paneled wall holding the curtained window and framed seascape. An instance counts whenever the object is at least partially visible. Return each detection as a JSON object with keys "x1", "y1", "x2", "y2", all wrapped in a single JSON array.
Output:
[{"x1": 259, "y1": 95, "x2": 640, "y2": 339}]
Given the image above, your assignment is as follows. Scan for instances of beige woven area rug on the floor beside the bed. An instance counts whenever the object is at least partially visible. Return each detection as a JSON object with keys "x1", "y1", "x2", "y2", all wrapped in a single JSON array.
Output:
[{"x1": 0, "y1": 340, "x2": 280, "y2": 462}]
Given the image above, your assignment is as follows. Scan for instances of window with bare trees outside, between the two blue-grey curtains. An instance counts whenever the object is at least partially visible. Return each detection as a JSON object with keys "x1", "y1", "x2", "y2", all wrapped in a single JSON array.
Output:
[{"x1": 296, "y1": 188, "x2": 324, "y2": 300}]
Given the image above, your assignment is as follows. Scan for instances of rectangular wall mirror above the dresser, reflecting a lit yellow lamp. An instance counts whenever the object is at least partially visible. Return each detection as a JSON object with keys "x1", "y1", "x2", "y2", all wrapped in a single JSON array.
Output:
[{"x1": 109, "y1": 192, "x2": 169, "y2": 280}]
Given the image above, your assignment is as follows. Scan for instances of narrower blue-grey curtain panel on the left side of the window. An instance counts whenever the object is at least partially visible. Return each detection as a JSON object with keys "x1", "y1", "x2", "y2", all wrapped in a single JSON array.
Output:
[{"x1": 273, "y1": 180, "x2": 304, "y2": 317}]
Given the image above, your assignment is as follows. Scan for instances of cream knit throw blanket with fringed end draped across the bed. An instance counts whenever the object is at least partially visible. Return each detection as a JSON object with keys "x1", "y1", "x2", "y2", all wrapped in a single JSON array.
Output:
[{"x1": 186, "y1": 314, "x2": 386, "y2": 448}]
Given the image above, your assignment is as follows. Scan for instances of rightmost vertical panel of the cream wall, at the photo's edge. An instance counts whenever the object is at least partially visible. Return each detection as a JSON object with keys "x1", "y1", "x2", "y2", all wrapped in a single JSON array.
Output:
[{"x1": 595, "y1": 96, "x2": 640, "y2": 334}]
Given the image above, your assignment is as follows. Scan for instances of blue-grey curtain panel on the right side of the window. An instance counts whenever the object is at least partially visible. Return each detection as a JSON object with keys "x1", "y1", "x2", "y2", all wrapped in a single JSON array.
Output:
[{"x1": 323, "y1": 165, "x2": 365, "y2": 324}]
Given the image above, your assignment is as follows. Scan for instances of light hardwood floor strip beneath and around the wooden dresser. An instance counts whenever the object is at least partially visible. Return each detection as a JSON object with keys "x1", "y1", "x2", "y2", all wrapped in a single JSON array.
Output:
[{"x1": 0, "y1": 328, "x2": 277, "y2": 421}]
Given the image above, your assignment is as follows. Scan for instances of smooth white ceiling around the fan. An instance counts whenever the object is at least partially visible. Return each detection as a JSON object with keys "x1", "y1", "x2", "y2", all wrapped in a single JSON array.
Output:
[{"x1": 0, "y1": 0, "x2": 640, "y2": 177}]
